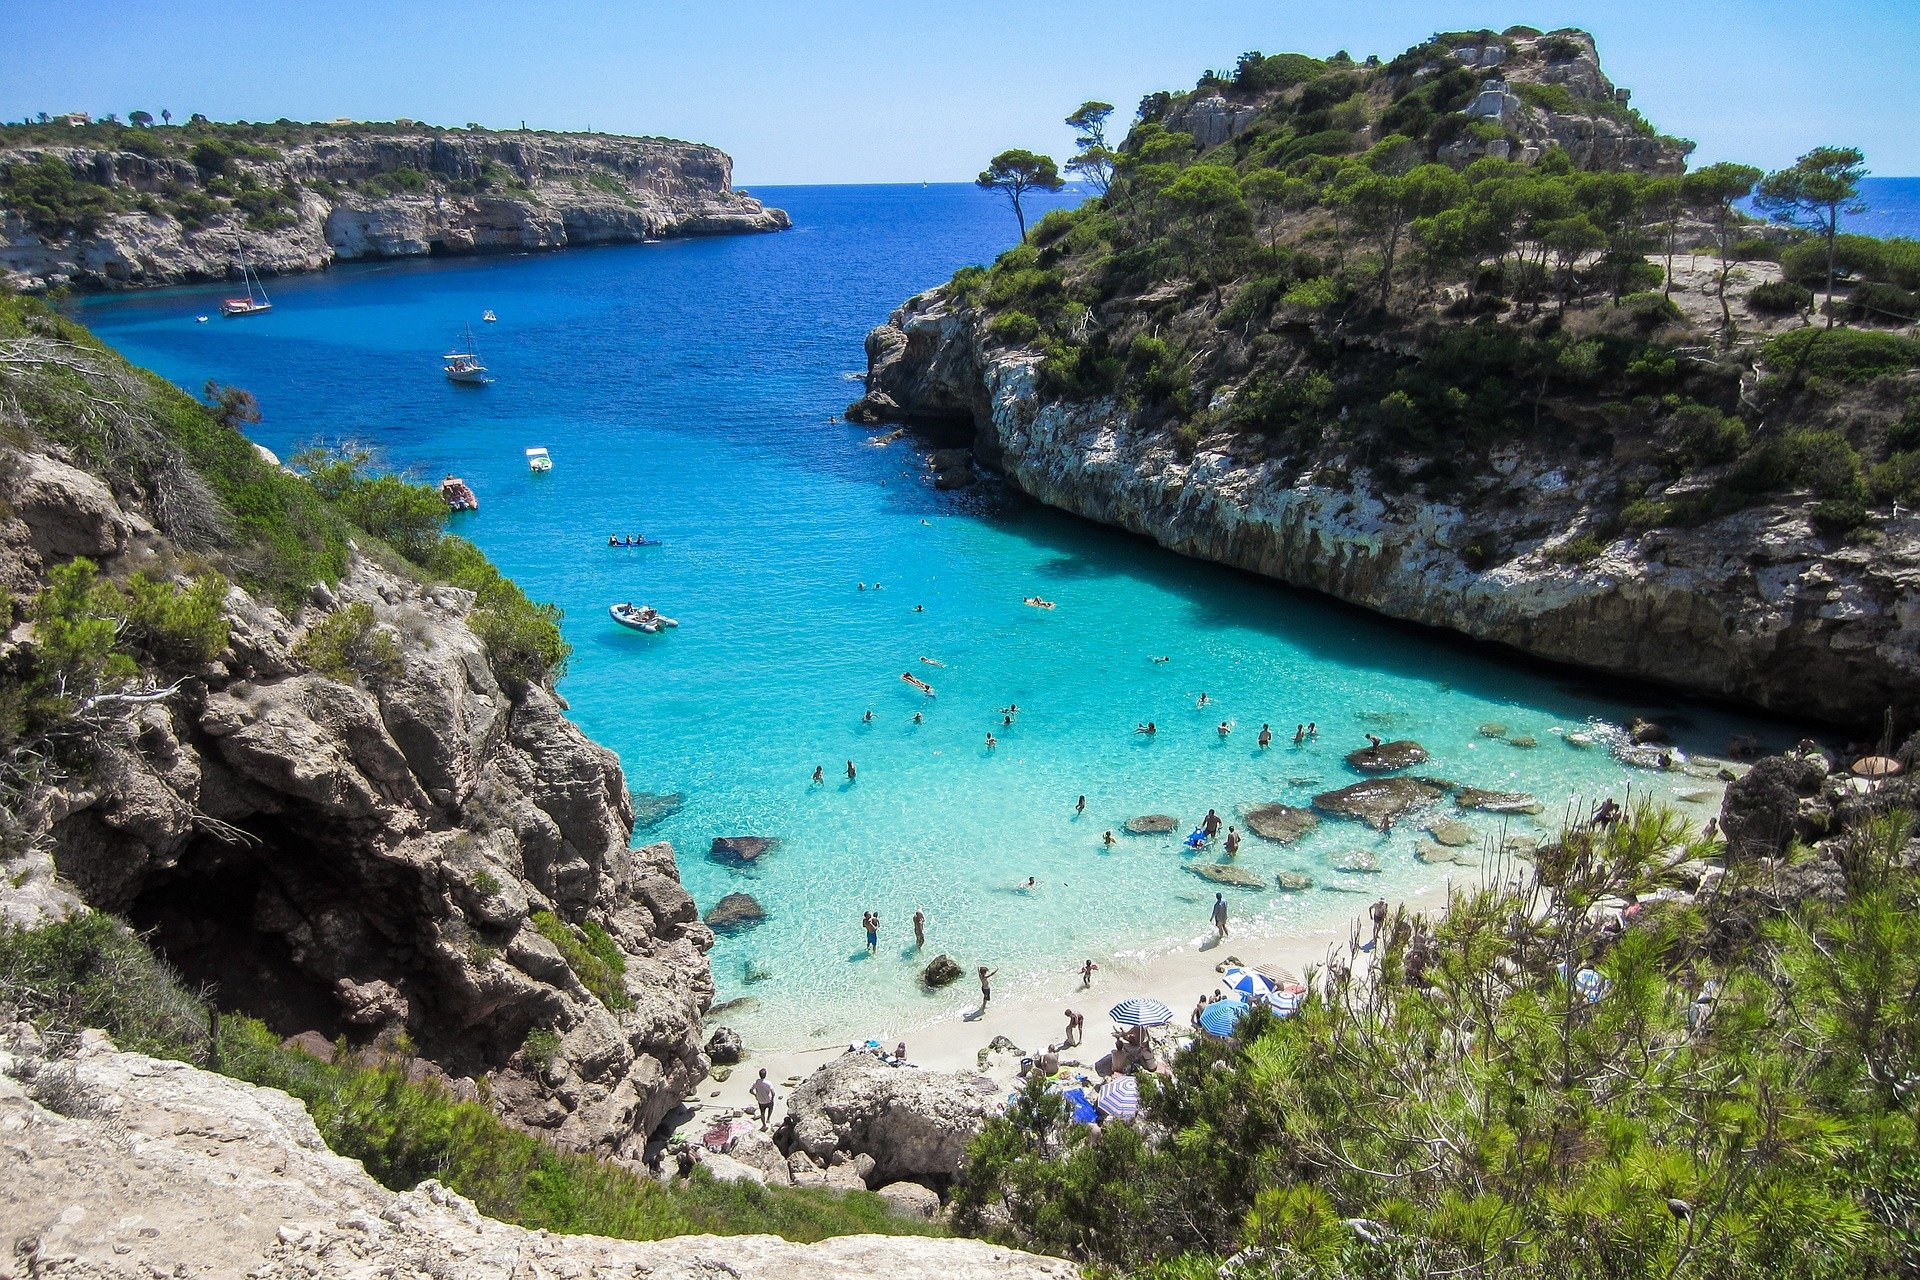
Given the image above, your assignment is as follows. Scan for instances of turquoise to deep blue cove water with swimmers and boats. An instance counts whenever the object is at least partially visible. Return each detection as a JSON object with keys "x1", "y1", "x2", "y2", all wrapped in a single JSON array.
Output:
[{"x1": 67, "y1": 186, "x2": 1780, "y2": 1044}]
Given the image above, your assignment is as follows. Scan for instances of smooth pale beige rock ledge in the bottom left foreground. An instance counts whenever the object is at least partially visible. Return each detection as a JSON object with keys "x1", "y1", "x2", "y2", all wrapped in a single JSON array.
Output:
[{"x1": 0, "y1": 1036, "x2": 1079, "y2": 1280}]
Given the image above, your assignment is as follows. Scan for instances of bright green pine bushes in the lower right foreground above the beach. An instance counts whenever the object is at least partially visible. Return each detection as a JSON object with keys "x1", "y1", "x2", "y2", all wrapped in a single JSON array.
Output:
[{"x1": 956, "y1": 786, "x2": 1920, "y2": 1280}]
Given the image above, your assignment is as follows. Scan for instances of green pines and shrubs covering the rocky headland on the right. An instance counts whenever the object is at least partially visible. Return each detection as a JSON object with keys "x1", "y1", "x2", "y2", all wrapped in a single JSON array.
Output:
[{"x1": 921, "y1": 29, "x2": 1920, "y2": 545}]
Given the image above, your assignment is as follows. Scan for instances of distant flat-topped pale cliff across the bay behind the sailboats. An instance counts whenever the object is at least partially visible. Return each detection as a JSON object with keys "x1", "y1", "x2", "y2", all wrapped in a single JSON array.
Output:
[{"x1": 0, "y1": 127, "x2": 789, "y2": 288}]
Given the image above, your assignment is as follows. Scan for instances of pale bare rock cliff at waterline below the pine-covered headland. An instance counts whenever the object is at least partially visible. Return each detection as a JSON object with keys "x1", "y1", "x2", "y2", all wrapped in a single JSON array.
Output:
[{"x1": 851, "y1": 290, "x2": 1920, "y2": 725}]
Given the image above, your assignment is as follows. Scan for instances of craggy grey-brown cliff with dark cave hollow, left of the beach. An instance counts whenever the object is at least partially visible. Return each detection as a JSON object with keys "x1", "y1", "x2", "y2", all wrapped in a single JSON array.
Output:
[{"x1": 0, "y1": 435, "x2": 712, "y2": 1153}]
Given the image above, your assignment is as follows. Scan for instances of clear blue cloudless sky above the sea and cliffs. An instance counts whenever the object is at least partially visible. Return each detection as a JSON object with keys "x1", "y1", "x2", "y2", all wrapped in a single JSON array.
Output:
[{"x1": 15, "y1": 0, "x2": 1920, "y2": 186}]
